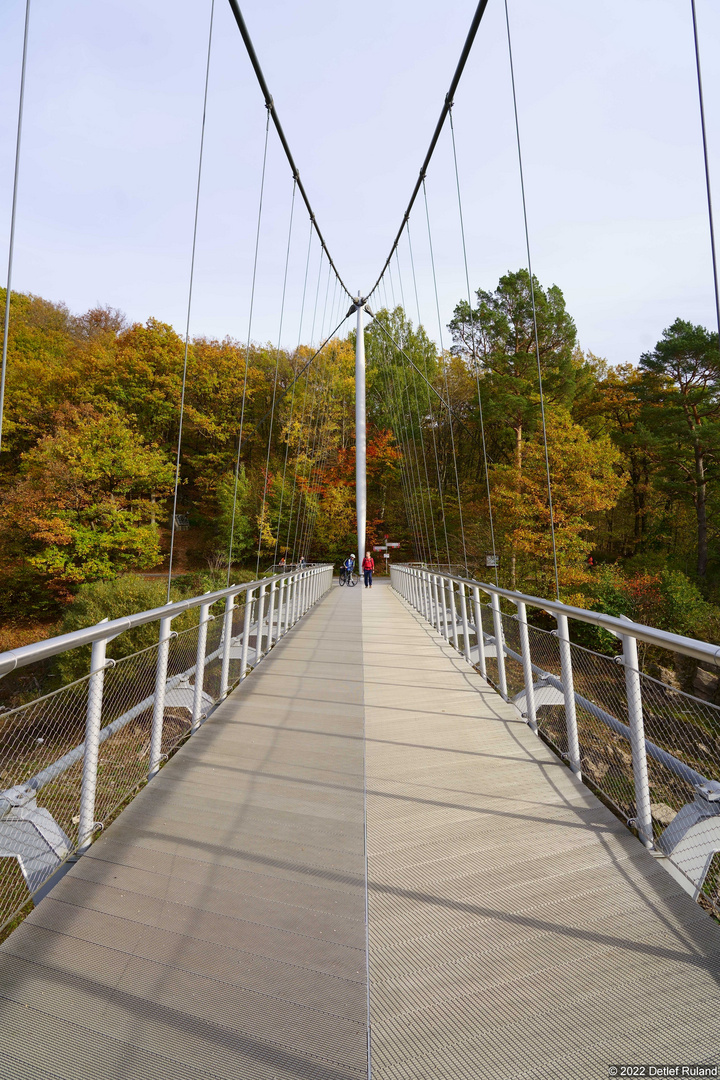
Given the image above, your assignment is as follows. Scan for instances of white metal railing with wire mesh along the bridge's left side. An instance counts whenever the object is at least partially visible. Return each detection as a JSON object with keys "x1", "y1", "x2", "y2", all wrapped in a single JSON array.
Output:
[{"x1": 0, "y1": 565, "x2": 332, "y2": 929}]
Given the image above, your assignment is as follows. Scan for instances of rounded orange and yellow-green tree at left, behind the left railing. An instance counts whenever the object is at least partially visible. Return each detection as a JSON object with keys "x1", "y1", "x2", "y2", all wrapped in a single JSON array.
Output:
[{"x1": 0, "y1": 406, "x2": 174, "y2": 602}]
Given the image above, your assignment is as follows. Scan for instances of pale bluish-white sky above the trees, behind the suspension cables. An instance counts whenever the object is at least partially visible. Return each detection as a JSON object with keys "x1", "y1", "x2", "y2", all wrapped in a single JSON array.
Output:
[{"x1": 0, "y1": 0, "x2": 720, "y2": 364}]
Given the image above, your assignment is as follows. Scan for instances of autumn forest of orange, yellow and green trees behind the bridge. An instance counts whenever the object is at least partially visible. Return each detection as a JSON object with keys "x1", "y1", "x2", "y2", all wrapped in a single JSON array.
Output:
[{"x1": 0, "y1": 270, "x2": 720, "y2": 648}]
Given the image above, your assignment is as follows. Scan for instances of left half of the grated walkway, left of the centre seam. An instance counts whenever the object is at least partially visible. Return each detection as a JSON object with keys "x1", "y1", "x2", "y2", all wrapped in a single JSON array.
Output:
[{"x1": 0, "y1": 590, "x2": 367, "y2": 1080}]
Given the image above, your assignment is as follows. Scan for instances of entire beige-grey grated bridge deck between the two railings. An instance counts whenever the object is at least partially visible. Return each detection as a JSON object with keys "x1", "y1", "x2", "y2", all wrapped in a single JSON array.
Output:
[{"x1": 0, "y1": 582, "x2": 720, "y2": 1080}]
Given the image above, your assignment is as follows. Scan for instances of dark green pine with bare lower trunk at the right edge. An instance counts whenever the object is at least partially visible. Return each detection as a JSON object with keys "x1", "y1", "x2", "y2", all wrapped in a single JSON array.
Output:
[{"x1": 640, "y1": 319, "x2": 720, "y2": 579}]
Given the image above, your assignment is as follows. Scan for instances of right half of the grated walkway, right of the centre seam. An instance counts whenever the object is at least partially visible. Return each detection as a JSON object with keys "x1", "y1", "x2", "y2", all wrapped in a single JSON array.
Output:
[{"x1": 363, "y1": 591, "x2": 720, "y2": 1080}]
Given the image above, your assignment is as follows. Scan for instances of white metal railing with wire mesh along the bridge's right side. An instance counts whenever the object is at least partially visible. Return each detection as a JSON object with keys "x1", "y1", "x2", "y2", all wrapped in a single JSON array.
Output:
[{"x1": 391, "y1": 565, "x2": 720, "y2": 913}]
